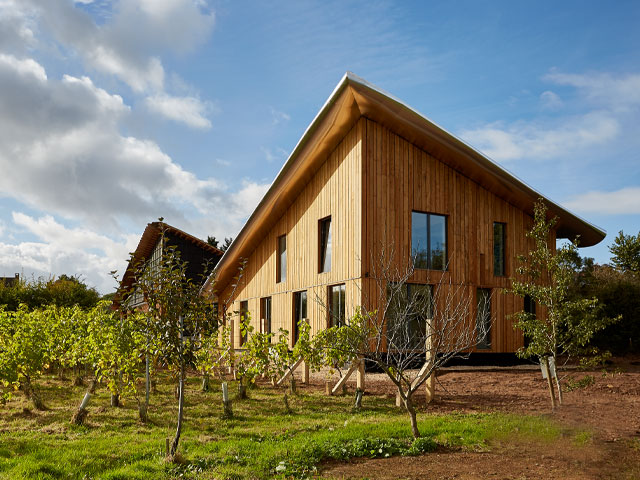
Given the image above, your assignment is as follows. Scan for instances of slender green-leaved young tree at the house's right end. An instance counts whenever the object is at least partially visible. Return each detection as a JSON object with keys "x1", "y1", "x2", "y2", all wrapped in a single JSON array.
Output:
[{"x1": 509, "y1": 200, "x2": 618, "y2": 408}]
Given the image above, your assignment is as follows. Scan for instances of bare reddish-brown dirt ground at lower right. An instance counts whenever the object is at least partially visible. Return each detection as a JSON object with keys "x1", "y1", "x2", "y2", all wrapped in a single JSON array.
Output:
[{"x1": 308, "y1": 357, "x2": 640, "y2": 480}]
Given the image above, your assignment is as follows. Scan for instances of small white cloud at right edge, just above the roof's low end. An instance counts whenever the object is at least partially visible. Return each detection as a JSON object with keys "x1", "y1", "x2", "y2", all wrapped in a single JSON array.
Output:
[{"x1": 564, "y1": 187, "x2": 640, "y2": 215}]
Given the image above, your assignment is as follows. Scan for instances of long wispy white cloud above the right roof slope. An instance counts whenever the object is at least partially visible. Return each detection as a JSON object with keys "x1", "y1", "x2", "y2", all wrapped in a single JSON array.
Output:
[{"x1": 460, "y1": 111, "x2": 619, "y2": 162}]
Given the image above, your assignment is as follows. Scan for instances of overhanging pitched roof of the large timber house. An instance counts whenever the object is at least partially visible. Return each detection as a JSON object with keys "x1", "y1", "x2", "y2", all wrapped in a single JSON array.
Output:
[{"x1": 203, "y1": 72, "x2": 606, "y2": 296}]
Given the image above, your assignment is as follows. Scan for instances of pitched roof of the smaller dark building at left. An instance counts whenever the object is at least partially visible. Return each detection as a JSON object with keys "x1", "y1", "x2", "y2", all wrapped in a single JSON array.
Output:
[{"x1": 114, "y1": 222, "x2": 223, "y2": 304}]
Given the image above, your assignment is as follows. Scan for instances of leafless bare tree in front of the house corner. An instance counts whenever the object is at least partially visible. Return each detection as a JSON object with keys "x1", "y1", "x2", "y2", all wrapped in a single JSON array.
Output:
[{"x1": 322, "y1": 248, "x2": 491, "y2": 437}]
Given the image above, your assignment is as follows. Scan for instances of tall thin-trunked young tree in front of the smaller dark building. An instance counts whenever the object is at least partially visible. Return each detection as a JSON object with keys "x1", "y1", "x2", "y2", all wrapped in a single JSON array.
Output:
[{"x1": 135, "y1": 236, "x2": 217, "y2": 457}]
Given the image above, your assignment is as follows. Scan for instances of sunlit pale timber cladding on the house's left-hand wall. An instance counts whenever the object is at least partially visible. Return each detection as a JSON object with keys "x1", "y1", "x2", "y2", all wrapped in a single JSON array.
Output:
[{"x1": 219, "y1": 118, "x2": 365, "y2": 347}]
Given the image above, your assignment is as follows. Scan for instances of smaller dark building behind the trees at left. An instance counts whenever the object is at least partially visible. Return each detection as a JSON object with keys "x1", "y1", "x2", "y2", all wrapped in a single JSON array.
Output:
[{"x1": 113, "y1": 222, "x2": 224, "y2": 308}]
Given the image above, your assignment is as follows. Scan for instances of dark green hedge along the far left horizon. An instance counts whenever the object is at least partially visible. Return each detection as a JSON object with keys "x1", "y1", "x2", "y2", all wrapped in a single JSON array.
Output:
[{"x1": 0, "y1": 275, "x2": 100, "y2": 311}]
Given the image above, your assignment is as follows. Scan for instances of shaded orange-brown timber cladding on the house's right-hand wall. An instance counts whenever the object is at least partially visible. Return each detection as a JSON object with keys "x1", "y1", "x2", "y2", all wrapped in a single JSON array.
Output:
[{"x1": 362, "y1": 119, "x2": 532, "y2": 352}]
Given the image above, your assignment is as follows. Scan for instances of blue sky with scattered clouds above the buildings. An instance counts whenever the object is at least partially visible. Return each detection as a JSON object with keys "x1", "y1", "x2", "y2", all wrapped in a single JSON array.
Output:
[{"x1": 0, "y1": 0, "x2": 640, "y2": 293}]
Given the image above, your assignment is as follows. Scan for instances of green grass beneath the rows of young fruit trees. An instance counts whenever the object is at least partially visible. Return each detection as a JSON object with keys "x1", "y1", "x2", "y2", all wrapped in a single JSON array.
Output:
[{"x1": 0, "y1": 378, "x2": 583, "y2": 479}]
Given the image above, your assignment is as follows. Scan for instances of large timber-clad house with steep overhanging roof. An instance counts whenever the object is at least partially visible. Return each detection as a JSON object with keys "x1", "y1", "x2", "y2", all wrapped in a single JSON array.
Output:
[{"x1": 204, "y1": 73, "x2": 605, "y2": 353}]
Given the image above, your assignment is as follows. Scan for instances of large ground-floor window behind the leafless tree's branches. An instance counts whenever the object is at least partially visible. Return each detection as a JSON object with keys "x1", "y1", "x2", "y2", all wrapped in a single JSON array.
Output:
[{"x1": 387, "y1": 283, "x2": 433, "y2": 350}]
